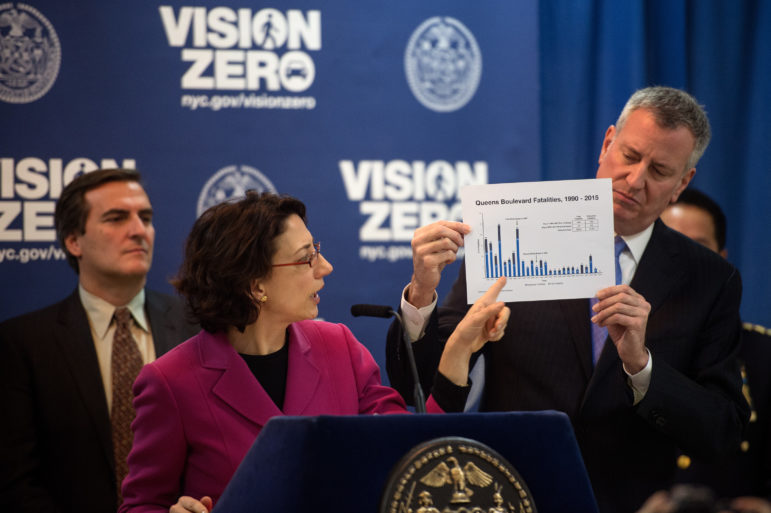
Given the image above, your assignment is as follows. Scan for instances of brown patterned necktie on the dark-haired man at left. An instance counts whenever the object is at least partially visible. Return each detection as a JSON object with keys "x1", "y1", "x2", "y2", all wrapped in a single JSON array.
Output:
[{"x1": 110, "y1": 307, "x2": 142, "y2": 498}]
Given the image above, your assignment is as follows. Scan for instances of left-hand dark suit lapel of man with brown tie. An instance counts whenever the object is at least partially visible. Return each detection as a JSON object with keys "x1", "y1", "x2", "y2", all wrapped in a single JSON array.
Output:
[{"x1": 54, "y1": 290, "x2": 115, "y2": 468}]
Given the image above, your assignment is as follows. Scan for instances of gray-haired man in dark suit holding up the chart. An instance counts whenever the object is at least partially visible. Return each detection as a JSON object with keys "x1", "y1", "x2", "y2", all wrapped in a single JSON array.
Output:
[{"x1": 387, "y1": 87, "x2": 748, "y2": 513}]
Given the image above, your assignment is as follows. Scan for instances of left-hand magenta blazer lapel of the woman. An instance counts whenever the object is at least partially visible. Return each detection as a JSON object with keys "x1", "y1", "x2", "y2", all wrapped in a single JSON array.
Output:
[{"x1": 198, "y1": 331, "x2": 281, "y2": 426}]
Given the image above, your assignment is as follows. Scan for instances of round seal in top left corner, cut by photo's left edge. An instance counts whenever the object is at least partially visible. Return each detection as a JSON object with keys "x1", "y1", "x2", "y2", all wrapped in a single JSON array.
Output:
[{"x1": 0, "y1": 2, "x2": 61, "y2": 103}]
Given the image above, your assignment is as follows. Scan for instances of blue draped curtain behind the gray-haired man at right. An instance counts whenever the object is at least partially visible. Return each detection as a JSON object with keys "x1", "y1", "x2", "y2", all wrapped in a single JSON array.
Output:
[{"x1": 539, "y1": 0, "x2": 771, "y2": 326}]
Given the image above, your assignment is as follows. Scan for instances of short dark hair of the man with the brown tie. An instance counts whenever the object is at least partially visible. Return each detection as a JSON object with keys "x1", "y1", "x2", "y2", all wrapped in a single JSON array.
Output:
[{"x1": 54, "y1": 169, "x2": 142, "y2": 273}]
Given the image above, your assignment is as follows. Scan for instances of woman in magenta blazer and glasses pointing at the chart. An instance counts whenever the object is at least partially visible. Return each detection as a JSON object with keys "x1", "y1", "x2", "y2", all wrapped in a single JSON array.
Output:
[{"x1": 120, "y1": 192, "x2": 508, "y2": 513}]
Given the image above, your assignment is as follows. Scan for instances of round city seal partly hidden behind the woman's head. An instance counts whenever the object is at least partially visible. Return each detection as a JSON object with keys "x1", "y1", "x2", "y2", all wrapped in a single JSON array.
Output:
[{"x1": 196, "y1": 165, "x2": 278, "y2": 216}]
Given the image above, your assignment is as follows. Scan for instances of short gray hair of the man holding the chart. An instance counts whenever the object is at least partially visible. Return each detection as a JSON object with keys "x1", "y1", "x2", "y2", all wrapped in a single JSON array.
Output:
[{"x1": 616, "y1": 86, "x2": 712, "y2": 170}]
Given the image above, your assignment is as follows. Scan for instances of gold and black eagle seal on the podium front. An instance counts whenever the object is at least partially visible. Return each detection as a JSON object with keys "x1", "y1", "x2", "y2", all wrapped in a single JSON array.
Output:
[{"x1": 380, "y1": 437, "x2": 536, "y2": 513}]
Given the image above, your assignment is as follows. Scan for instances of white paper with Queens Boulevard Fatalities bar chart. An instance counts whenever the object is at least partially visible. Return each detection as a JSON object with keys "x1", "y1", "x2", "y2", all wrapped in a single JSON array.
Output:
[{"x1": 461, "y1": 178, "x2": 616, "y2": 304}]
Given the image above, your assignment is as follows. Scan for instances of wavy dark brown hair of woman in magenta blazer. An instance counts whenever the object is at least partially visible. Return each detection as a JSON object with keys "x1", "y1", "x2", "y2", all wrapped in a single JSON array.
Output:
[{"x1": 172, "y1": 191, "x2": 305, "y2": 333}]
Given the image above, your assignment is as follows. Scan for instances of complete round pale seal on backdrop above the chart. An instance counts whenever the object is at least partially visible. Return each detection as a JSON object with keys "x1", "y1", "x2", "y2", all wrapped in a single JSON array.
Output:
[{"x1": 404, "y1": 17, "x2": 482, "y2": 112}]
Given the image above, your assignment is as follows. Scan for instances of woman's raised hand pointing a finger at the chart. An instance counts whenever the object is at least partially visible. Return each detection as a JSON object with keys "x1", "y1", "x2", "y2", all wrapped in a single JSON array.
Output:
[{"x1": 439, "y1": 276, "x2": 511, "y2": 386}]
